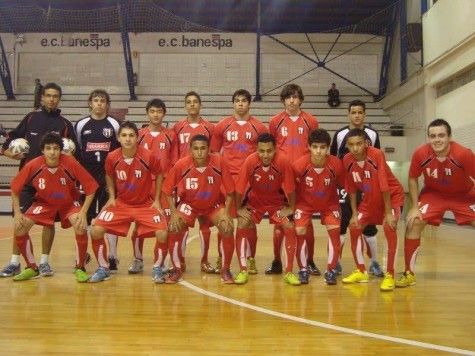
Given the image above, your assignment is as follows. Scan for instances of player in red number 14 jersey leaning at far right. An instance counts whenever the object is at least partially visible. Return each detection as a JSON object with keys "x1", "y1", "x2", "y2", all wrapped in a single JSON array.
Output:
[{"x1": 396, "y1": 119, "x2": 475, "y2": 287}]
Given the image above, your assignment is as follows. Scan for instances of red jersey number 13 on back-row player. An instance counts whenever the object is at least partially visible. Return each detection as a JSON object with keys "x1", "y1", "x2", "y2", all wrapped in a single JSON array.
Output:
[{"x1": 210, "y1": 116, "x2": 267, "y2": 175}]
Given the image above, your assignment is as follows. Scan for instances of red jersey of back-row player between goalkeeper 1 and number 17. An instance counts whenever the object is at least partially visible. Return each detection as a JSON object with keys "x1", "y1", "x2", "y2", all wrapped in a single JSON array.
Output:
[{"x1": 139, "y1": 126, "x2": 178, "y2": 173}]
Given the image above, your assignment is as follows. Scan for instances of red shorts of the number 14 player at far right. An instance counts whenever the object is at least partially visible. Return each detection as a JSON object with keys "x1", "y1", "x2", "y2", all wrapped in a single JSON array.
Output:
[{"x1": 418, "y1": 190, "x2": 475, "y2": 226}]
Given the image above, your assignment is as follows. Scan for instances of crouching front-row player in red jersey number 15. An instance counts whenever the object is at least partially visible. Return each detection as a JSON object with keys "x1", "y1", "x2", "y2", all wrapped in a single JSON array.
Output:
[{"x1": 162, "y1": 134, "x2": 234, "y2": 284}]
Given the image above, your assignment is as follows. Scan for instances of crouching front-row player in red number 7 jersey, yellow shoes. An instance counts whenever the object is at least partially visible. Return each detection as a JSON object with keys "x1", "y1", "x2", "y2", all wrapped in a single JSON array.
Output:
[{"x1": 234, "y1": 133, "x2": 300, "y2": 286}]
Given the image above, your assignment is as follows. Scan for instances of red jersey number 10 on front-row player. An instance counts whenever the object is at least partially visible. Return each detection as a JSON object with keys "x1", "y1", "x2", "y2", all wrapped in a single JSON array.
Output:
[{"x1": 105, "y1": 146, "x2": 162, "y2": 205}]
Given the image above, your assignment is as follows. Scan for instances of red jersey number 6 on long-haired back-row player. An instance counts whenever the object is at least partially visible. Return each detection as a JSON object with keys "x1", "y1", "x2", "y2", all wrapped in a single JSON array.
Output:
[{"x1": 269, "y1": 111, "x2": 318, "y2": 162}]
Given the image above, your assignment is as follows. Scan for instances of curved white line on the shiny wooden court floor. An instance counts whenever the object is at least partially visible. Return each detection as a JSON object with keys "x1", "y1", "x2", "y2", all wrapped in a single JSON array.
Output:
[{"x1": 185, "y1": 235, "x2": 475, "y2": 356}]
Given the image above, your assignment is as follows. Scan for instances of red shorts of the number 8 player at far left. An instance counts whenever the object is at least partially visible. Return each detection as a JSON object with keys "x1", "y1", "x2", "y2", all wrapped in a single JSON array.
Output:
[{"x1": 23, "y1": 201, "x2": 81, "y2": 229}]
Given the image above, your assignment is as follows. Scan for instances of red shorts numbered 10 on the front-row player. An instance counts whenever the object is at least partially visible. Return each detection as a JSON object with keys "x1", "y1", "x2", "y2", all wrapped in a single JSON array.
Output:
[{"x1": 93, "y1": 202, "x2": 167, "y2": 237}]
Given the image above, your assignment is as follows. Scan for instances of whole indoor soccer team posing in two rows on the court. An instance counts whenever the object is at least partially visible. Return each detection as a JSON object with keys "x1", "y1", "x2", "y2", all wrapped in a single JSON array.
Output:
[{"x1": 0, "y1": 83, "x2": 475, "y2": 291}]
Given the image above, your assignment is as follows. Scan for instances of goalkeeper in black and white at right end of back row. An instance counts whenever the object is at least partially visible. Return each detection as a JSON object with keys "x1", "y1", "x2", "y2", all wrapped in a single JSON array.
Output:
[{"x1": 330, "y1": 100, "x2": 384, "y2": 277}]
